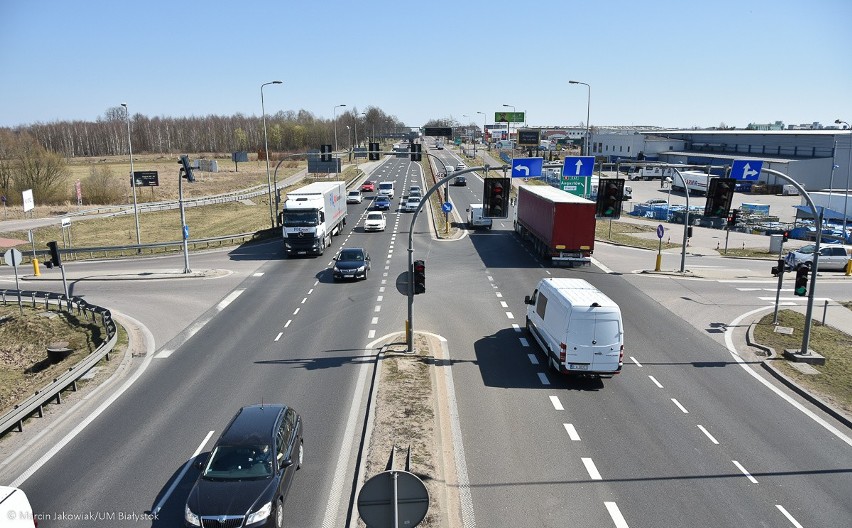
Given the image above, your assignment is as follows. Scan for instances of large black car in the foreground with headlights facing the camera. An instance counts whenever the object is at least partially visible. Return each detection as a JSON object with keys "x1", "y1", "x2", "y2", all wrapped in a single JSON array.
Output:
[{"x1": 184, "y1": 404, "x2": 304, "y2": 528}]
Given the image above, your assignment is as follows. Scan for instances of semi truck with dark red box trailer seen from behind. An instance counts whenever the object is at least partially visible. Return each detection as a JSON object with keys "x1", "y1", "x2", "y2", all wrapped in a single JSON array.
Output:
[{"x1": 514, "y1": 185, "x2": 595, "y2": 267}]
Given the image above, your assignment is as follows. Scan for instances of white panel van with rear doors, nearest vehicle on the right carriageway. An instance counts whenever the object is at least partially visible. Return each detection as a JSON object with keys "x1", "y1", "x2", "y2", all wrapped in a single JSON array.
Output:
[{"x1": 524, "y1": 278, "x2": 624, "y2": 377}]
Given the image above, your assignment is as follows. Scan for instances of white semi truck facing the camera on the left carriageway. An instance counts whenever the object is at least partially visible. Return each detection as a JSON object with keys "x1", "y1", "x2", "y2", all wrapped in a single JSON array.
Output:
[{"x1": 280, "y1": 181, "x2": 346, "y2": 255}]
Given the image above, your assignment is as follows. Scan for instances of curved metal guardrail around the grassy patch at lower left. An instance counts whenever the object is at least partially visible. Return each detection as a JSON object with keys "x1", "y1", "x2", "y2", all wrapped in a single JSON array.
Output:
[{"x1": 0, "y1": 289, "x2": 118, "y2": 436}]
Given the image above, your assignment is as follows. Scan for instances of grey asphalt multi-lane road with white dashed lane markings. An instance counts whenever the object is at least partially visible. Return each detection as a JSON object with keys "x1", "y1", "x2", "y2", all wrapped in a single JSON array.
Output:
[{"x1": 0, "y1": 151, "x2": 852, "y2": 528}]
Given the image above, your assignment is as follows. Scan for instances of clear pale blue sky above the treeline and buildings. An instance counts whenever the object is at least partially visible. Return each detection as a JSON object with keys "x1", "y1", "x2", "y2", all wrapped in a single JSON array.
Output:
[{"x1": 0, "y1": 0, "x2": 852, "y2": 127}]
